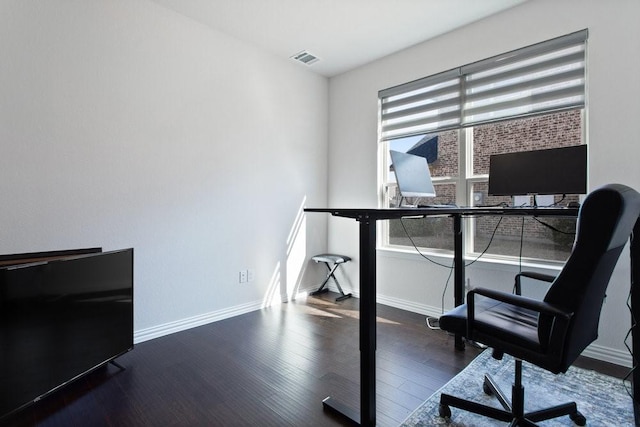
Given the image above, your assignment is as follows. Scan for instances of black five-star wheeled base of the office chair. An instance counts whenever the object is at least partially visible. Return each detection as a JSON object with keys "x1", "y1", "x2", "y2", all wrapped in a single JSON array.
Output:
[{"x1": 439, "y1": 375, "x2": 587, "y2": 427}]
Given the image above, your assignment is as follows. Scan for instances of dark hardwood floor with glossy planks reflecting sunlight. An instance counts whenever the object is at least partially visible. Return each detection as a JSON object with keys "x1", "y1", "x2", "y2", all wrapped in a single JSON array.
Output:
[{"x1": 4, "y1": 293, "x2": 627, "y2": 427}]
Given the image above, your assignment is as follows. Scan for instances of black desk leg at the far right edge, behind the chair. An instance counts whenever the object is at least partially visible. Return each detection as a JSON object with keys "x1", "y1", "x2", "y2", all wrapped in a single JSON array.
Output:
[{"x1": 629, "y1": 219, "x2": 640, "y2": 425}]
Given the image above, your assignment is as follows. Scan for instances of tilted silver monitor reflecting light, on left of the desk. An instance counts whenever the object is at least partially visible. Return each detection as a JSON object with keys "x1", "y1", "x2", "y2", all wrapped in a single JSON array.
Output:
[{"x1": 389, "y1": 150, "x2": 436, "y2": 197}]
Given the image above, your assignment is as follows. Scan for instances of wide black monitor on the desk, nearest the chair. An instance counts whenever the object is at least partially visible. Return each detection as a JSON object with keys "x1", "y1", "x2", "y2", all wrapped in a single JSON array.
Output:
[{"x1": 489, "y1": 144, "x2": 587, "y2": 196}]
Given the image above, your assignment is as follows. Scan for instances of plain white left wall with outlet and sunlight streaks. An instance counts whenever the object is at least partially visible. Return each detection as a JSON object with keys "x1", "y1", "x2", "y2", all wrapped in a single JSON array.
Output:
[{"x1": 0, "y1": 0, "x2": 328, "y2": 341}]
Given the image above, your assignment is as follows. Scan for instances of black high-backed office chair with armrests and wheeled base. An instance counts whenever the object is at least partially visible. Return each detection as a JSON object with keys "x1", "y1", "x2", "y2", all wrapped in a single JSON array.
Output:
[{"x1": 440, "y1": 184, "x2": 640, "y2": 426}]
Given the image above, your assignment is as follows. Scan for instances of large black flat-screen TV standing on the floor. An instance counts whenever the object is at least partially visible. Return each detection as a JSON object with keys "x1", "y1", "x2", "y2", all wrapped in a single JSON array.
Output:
[{"x1": 0, "y1": 249, "x2": 133, "y2": 421}]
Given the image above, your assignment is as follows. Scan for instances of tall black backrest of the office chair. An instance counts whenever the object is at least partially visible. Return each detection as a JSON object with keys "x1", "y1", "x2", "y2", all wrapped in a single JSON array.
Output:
[{"x1": 538, "y1": 184, "x2": 640, "y2": 371}]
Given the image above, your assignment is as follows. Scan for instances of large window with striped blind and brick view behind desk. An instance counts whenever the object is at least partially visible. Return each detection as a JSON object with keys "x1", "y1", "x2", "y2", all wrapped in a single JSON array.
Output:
[{"x1": 379, "y1": 30, "x2": 587, "y2": 261}]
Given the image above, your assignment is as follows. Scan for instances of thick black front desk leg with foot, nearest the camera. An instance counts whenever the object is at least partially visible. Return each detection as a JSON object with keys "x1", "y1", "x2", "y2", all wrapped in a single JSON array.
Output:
[{"x1": 322, "y1": 218, "x2": 377, "y2": 426}]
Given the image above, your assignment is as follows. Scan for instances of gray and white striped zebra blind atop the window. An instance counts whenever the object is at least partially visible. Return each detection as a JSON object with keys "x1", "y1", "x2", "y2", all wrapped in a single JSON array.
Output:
[{"x1": 378, "y1": 30, "x2": 587, "y2": 140}]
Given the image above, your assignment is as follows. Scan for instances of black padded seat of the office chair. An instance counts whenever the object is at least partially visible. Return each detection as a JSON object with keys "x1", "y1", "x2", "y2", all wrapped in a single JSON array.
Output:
[{"x1": 440, "y1": 295, "x2": 541, "y2": 352}]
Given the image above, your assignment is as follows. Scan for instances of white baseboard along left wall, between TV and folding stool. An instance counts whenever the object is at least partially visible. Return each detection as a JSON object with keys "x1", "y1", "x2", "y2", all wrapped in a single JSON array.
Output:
[{"x1": 133, "y1": 301, "x2": 263, "y2": 344}]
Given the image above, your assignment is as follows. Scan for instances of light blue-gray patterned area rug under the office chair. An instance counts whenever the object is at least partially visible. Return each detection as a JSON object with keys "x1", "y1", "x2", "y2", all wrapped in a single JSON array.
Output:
[{"x1": 402, "y1": 349, "x2": 634, "y2": 427}]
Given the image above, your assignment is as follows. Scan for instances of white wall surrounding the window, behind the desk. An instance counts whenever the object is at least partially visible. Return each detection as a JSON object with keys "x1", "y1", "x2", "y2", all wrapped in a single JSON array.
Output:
[{"x1": 329, "y1": 0, "x2": 640, "y2": 364}]
